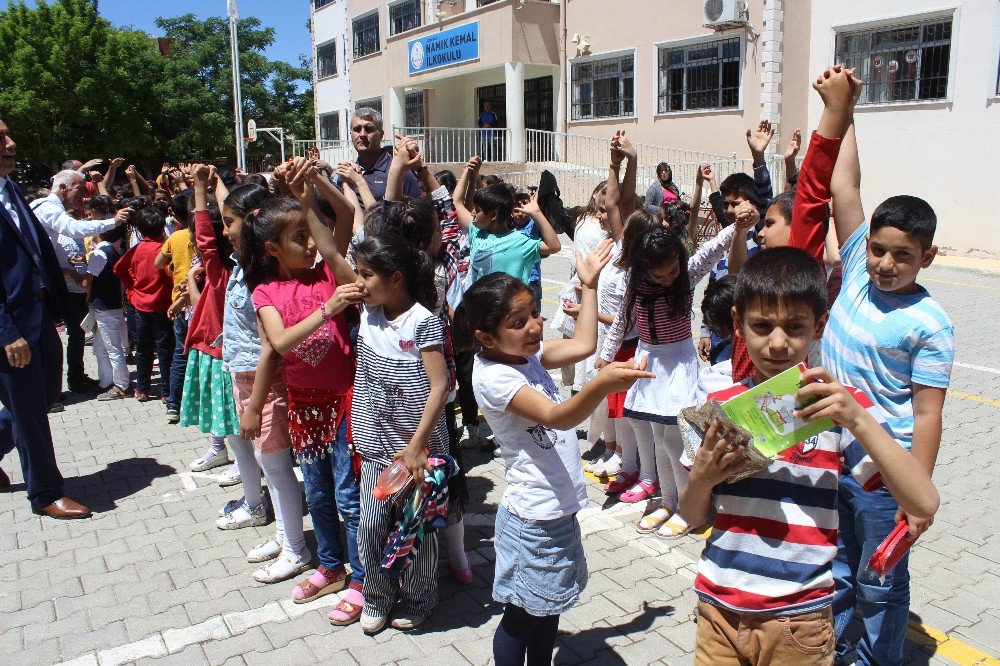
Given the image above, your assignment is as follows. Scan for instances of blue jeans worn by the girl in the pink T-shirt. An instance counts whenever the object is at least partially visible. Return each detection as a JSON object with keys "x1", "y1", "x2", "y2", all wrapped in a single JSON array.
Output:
[{"x1": 299, "y1": 420, "x2": 365, "y2": 583}]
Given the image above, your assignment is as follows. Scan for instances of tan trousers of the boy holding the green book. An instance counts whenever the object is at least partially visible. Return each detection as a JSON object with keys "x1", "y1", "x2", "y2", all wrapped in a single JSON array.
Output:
[{"x1": 694, "y1": 601, "x2": 837, "y2": 666}]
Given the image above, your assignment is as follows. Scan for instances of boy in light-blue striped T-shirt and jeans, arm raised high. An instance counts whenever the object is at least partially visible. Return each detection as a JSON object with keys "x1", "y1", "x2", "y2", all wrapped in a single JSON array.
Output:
[{"x1": 792, "y1": 67, "x2": 954, "y2": 665}]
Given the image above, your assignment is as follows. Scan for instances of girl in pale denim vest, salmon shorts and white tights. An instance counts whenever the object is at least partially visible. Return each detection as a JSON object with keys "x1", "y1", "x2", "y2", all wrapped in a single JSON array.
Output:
[{"x1": 222, "y1": 185, "x2": 312, "y2": 583}]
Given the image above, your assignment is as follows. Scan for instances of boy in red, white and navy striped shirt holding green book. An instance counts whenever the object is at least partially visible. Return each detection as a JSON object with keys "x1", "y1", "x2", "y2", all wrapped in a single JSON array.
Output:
[{"x1": 680, "y1": 247, "x2": 939, "y2": 666}]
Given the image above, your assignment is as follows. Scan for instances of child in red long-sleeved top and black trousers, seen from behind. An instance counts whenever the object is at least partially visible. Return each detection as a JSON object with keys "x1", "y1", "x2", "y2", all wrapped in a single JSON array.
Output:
[{"x1": 114, "y1": 208, "x2": 174, "y2": 402}]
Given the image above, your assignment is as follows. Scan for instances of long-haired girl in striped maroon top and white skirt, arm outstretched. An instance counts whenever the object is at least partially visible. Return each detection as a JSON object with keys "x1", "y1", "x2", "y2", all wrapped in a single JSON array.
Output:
[{"x1": 597, "y1": 215, "x2": 749, "y2": 538}]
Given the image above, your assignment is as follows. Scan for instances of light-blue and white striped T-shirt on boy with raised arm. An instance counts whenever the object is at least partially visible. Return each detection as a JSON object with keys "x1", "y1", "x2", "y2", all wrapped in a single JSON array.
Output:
[{"x1": 823, "y1": 222, "x2": 955, "y2": 450}]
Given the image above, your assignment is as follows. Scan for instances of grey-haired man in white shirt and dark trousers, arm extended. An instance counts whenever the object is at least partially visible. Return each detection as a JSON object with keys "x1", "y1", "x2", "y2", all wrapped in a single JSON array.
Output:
[{"x1": 31, "y1": 169, "x2": 129, "y2": 393}]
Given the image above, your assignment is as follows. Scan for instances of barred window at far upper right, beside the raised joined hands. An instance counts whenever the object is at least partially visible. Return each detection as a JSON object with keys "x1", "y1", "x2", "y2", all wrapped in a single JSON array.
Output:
[{"x1": 834, "y1": 18, "x2": 951, "y2": 104}]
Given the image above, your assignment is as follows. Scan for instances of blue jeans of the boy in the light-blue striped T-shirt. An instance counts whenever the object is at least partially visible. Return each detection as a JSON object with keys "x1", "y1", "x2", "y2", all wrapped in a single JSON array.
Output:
[{"x1": 833, "y1": 476, "x2": 910, "y2": 666}]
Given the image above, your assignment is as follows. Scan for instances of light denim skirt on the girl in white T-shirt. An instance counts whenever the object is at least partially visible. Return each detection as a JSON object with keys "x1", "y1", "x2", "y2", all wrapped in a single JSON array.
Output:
[{"x1": 493, "y1": 505, "x2": 587, "y2": 617}]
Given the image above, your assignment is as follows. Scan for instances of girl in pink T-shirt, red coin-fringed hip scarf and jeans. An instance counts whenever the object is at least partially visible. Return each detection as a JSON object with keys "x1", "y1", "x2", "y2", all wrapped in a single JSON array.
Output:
[{"x1": 247, "y1": 158, "x2": 365, "y2": 625}]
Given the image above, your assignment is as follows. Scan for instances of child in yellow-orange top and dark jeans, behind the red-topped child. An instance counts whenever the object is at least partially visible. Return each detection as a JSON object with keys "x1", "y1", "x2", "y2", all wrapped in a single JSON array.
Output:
[{"x1": 154, "y1": 194, "x2": 195, "y2": 423}]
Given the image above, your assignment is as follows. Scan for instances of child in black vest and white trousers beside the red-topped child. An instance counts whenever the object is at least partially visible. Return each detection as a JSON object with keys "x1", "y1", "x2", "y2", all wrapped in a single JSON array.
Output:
[{"x1": 83, "y1": 223, "x2": 130, "y2": 401}]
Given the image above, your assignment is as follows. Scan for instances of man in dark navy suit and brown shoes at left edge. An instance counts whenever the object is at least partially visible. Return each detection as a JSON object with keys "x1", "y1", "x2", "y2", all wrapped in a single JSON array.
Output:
[{"x1": 0, "y1": 119, "x2": 90, "y2": 518}]
